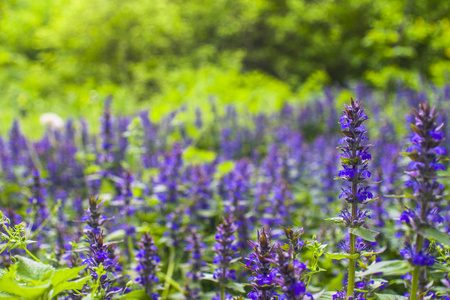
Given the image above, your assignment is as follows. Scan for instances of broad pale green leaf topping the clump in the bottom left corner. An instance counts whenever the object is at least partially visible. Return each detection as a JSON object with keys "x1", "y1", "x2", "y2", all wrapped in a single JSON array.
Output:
[{"x1": 16, "y1": 256, "x2": 55, "y2": 281}]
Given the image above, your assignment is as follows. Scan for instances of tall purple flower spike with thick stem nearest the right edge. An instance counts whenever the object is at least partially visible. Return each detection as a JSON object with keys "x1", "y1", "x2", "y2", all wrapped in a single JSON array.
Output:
[{"x1": 401, "y1": 102, "x2": 446, "y2": 300}]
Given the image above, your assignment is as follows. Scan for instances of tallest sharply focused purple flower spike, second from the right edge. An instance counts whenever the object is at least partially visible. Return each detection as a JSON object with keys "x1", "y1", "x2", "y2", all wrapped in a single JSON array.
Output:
[{"x1": 338, "y1": 99, "x2": 373, "y2": 297}]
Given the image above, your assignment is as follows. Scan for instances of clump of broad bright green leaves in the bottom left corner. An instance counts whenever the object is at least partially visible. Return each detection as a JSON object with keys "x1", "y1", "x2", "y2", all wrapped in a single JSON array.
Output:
[{"x1": 0, "y1": 256, "x2": 91, "y2": 300}]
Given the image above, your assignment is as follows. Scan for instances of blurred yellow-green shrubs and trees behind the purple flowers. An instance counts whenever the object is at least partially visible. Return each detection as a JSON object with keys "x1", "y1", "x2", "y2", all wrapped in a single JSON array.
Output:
[{"x1": 0, "y1": 0, "x2": 450, "y2": 133}]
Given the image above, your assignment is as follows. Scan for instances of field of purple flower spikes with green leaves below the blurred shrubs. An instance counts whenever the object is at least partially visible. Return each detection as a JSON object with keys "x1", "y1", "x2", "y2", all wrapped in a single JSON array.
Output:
[{"x1": 0, "y1": 87, "x2": 450, "y2": 300}]
